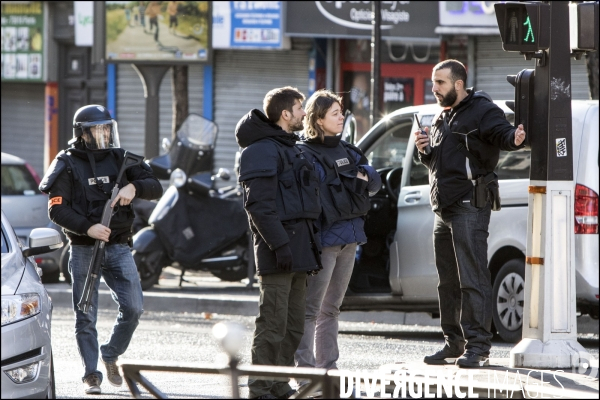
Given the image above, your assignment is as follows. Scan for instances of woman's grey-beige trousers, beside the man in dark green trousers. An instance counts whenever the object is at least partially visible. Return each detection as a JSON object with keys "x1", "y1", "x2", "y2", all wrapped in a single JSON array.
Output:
[{"x1": 295, "y1": 243, "x2": 356, "y2": 369}]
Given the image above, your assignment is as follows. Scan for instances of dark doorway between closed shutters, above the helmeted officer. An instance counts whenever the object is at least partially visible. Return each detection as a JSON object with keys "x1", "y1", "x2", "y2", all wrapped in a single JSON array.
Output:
[{"x1": 58, "y1": 44, "x2": 106, "y2": 149}]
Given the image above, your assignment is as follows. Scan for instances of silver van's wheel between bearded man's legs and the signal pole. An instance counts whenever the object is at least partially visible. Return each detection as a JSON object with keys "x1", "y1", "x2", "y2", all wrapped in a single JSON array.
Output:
[{"x1": 492, "y1": 259, "x2": 525, "y2": 343}]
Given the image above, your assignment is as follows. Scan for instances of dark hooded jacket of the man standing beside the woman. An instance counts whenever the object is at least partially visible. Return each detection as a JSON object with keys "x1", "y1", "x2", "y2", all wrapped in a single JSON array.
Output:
[{"x1": 235, "y1": 109, "x2": 321, "y2": 275}]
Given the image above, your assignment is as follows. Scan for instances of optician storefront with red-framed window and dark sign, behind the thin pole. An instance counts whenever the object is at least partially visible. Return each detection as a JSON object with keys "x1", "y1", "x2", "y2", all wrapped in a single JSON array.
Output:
[{"x1": 286, "y1": 1, "x2": 440, "y2": 138}]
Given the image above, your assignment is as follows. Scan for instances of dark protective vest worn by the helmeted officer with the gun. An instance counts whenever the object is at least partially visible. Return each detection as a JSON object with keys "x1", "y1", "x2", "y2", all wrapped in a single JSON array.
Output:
[{"x1": 59, "y1": 149, "x2": 134, "y2": 229}]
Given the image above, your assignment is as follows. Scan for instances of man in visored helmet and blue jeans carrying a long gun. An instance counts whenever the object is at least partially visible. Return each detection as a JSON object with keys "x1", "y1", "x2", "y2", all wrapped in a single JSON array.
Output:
[{"x1": 40, "y1": 105, "x2": 162, "y2": 394}]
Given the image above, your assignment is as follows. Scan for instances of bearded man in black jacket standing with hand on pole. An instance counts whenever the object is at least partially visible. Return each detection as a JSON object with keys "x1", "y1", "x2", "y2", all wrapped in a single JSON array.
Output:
[{"x1": 414, "y1": 60, "x2": 525, "y2": 368}]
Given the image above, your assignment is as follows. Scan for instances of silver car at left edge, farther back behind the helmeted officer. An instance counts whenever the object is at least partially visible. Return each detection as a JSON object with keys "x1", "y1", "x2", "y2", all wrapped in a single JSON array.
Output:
[{"x1": 2, "y1": 153, "x2": 66, "y2": 283}]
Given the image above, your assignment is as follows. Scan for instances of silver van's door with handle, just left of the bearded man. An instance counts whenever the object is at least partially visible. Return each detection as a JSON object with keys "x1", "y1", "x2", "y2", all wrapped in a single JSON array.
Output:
[{"x1": 390, "y1": 113, "x2": 438, "y2": 301}]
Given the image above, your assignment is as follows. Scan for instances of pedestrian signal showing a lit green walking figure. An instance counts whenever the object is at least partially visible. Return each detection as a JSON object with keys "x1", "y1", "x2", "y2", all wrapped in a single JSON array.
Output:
[{"x1": 494, "y1": 2, "x2": 550, "y2": 53}]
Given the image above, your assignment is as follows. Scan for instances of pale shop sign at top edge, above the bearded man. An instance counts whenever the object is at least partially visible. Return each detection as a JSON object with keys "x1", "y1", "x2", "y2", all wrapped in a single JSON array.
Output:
[{"x1": 439, "y1": 1, "x2": 499, "y2": 27}]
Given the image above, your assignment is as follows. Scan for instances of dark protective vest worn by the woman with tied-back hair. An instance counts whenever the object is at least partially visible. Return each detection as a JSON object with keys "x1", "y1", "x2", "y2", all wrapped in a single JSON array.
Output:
[{"x1": 301, "y1": 142, "x2": 371, "y2": 225}]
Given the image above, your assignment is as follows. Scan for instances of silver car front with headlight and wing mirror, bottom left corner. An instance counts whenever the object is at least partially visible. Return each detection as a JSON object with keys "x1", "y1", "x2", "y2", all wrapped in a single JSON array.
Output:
[{"x1": 0, "y1": 210, "x2": 63, "y2": 399}]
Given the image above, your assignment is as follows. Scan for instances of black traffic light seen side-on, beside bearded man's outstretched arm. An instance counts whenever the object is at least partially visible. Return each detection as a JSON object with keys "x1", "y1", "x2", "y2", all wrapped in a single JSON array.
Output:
[{"x1": 506, "y1": 69, "x2": 535, "y2": 145}]
